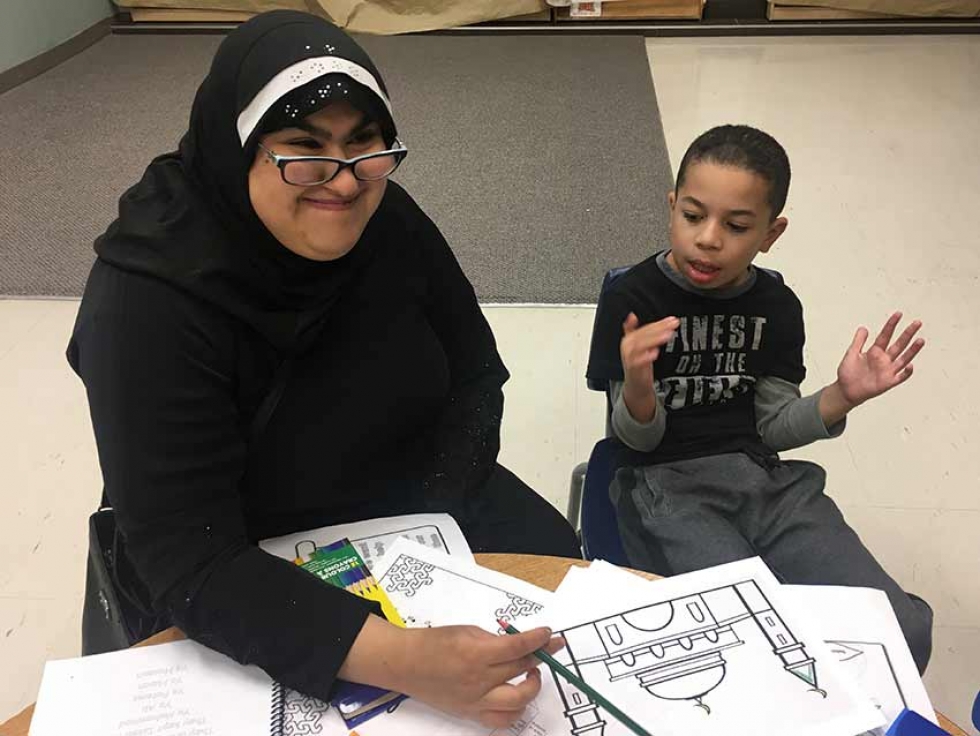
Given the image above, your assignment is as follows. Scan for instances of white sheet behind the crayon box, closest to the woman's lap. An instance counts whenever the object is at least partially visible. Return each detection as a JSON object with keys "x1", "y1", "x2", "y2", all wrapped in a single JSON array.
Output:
[{"x1": 259, "y1": 514, "x2": 473, "y2": 576}]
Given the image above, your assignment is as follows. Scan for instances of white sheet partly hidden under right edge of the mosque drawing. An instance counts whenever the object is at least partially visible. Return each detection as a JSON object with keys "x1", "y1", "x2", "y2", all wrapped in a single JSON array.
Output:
[{"x1": 783, "y1": 585, "x2": 939, "y2": 725}]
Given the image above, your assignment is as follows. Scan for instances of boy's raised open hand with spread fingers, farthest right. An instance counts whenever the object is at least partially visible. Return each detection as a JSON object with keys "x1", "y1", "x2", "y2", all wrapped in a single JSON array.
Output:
[{"x1": 837, "y1": 312, "x2": 926, "y2": 407}]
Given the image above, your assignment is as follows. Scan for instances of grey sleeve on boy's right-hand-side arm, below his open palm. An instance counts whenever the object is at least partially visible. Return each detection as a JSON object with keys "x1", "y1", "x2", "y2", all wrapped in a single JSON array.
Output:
[{"x1": 755, "y1": 376, "x2": 847, "y2": 452}]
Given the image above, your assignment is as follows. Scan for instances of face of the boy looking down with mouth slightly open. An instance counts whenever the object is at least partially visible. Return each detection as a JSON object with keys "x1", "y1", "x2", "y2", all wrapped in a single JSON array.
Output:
[{"x1": 667, "y1": 161, "x2": 788, "y2": 289}]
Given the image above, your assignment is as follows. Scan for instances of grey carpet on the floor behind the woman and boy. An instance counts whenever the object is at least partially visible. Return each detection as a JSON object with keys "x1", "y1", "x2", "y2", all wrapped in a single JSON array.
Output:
[{"x1": 0, "y1": 35, "x2": 670, "y2": 303}]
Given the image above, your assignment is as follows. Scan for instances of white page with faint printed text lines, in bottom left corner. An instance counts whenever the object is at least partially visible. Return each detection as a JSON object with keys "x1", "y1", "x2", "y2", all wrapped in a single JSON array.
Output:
[{"x1": 30, "y1": 641, "x2": 274, "y2": 736}]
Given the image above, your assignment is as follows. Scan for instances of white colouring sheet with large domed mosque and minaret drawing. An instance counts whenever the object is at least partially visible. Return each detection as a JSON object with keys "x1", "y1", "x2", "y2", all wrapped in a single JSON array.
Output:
[{"x1": 517, "y1": 558, "x2": 884, "y2": 736}]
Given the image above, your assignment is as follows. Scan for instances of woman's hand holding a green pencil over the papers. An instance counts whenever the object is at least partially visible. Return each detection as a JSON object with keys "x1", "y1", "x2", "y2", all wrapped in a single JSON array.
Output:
[{"x1": 340, "y1": 616, "x2": 565, "y2": 728}]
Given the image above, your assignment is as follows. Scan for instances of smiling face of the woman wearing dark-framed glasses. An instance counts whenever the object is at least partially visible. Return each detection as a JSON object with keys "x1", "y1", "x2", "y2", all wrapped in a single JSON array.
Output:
[{"x1": 248, "y1": 102, "x2": 387, "y2": 261}]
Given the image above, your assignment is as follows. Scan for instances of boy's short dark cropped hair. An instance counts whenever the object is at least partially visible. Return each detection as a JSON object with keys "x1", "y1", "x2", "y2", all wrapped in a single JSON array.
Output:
[{"x1": 675, "y1": 125, "x2": 790, "y2": 219}]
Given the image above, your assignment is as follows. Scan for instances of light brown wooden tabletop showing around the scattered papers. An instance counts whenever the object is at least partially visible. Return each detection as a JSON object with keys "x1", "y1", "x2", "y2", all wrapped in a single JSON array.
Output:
[{"x1": 0, "y1": 554, "x2": 969, "y2": 736}]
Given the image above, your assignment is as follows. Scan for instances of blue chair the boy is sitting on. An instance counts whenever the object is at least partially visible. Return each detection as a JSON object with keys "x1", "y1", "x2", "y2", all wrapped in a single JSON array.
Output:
[{"x1": 566, "y1": 266, "x2": 788, "y2": 568}]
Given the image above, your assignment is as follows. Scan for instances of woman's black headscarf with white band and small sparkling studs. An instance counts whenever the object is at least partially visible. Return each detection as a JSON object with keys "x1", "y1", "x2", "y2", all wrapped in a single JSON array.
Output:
[{"x1": 95, "y1": 11, "x2": 396, "y2": 353}]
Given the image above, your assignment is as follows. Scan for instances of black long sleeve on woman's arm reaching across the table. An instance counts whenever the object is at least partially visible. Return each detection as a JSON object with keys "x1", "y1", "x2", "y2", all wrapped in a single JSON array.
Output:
[{"x1": 69, "y1": 263, "x2": 373, "y2": 698}]
